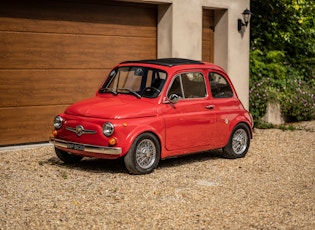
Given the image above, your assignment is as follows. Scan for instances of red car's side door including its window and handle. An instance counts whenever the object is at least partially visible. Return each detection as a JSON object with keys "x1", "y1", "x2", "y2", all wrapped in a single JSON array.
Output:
[{"x1": 164, "y1": 71, "x2": 215, "y2": 151}]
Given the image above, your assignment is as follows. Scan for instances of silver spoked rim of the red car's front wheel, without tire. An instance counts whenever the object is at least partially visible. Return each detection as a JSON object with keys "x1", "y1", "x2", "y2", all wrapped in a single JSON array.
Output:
[{"x1": 136, "y1": 139, "x2": 156, "y2": 169}]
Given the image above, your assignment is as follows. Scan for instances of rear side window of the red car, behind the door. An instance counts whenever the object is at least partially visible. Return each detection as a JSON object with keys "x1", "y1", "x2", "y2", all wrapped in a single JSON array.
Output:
[{"x1": 209, "y1": 73, "x2": 233, "y2": 98}]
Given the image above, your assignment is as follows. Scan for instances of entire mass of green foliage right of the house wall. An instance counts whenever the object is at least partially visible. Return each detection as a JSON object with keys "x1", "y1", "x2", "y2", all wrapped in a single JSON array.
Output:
[{"x1": 250, "y1": 0, "x2": 315, "y2": 120}]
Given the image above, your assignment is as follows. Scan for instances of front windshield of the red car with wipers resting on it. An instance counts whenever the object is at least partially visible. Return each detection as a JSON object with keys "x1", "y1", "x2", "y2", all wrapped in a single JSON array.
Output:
[{"x1": 99, "y1": 66, "x2": 167, "y2": 98}]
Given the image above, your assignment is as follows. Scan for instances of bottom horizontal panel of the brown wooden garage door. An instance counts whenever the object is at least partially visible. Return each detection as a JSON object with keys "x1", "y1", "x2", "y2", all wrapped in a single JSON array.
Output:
[{"x1": 0, "y1": 105, "x2": 66, "y2": 146}]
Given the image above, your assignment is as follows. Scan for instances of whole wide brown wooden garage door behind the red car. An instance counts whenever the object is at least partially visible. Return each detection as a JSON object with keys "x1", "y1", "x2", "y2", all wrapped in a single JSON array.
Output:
[{"x1": 0, "y1": 0, "x2": 157, "y2": 146}]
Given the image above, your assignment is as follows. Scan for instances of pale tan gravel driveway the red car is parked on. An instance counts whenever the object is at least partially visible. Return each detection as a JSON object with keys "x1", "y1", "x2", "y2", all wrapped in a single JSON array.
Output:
[{"x1": 0, "y1": 121, "x2": 315, "y2": 230}]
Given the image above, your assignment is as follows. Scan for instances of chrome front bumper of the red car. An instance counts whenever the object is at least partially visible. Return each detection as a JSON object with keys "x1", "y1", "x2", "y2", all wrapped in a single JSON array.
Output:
[{"x1": 49, "y1": 138, "x2": 122, "y2": 155}]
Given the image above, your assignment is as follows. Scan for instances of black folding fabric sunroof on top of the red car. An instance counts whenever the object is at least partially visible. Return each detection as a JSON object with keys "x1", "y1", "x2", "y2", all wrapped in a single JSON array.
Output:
[{"x1": 121, "y1": 58, "x2": 204, "y2": 67}]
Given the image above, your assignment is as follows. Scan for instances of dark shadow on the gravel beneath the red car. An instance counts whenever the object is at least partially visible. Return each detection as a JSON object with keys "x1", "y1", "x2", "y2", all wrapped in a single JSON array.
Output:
[{"x1": 42, "y1": 150, "x2": 222, "y2": 173}]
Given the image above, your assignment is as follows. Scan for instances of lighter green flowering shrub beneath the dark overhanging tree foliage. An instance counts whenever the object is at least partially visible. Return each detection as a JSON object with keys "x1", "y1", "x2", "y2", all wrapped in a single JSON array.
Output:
[{"x1": 249, "y1": 50, "x2": 315, "y2": 123}]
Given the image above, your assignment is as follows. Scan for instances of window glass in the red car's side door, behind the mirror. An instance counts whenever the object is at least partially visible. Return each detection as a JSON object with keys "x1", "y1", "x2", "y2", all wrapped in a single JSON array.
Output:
[{"x1": 167, "y1": 72, "x2": 207, "y2": 98}]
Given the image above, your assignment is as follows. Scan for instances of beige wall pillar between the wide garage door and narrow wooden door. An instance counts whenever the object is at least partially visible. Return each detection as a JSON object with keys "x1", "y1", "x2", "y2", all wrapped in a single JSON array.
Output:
[{"x1": 158, "y1": 0, "x2": 202, "y2": 60}]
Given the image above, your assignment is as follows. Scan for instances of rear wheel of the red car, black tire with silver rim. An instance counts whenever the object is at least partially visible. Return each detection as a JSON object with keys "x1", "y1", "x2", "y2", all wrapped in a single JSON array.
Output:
[{"x1": 223, "y1": 123, "x2": 250, "y2": 159}]
